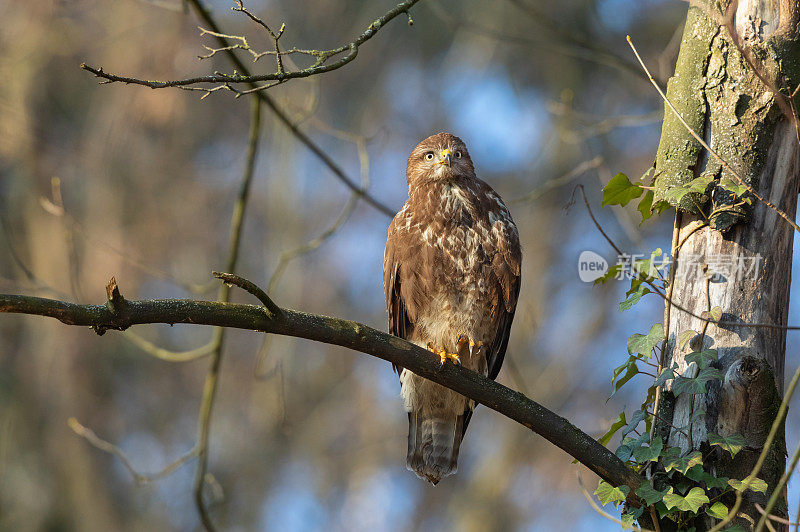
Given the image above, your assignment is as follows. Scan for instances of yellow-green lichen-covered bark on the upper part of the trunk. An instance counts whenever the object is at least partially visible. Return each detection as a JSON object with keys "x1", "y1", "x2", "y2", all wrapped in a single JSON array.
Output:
[{"x1": 655, "y1": 2, "x2": 780, "y2": 230}]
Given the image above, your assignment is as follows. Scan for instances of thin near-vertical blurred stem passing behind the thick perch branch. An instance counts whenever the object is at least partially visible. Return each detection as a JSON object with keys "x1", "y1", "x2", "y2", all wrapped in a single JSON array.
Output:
[{"x1": 194, "y1": 97, "x2": 261, "y2": 531}]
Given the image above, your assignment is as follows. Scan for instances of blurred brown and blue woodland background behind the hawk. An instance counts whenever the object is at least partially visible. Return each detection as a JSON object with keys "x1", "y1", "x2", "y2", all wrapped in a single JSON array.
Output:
[{"x1": 0, "y1": 0, "x2": 800, "y2": 531}]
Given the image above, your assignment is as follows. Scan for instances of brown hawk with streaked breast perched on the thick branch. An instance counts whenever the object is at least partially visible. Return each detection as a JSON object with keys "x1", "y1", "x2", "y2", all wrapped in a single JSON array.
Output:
[{"x1": 383, "y1": 133, "x2": 522, "y2": 485}]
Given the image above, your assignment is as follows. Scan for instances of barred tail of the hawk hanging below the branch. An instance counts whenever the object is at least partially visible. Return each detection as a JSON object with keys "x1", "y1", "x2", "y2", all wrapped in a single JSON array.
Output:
[{"x1": 406, "y1": 412, "x2": 465, "y2": 485}]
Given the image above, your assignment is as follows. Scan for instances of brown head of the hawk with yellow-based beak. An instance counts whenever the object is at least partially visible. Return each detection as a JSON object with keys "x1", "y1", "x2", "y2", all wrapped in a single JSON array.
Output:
[{"x1": 406, "y1": 133, "x2": 475, "y2": 185}]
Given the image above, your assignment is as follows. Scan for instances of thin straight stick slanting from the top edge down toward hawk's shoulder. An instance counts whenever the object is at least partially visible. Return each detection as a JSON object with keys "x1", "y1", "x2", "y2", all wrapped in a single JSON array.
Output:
[{"x1": 181, "y1": 0, "x2": 395, "y2": 218}]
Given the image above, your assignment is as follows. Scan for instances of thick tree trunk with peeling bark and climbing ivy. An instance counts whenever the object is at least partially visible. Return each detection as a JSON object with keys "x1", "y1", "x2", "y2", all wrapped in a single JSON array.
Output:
[{"x1": 655, "y1": 0, "x2": 800, "y2": 530}]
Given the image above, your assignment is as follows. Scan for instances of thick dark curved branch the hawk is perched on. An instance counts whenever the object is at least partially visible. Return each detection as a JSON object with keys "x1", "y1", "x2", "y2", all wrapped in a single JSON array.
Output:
[{"x1": 0, "y1": 276, "x2": 643, "y2": 506}]
